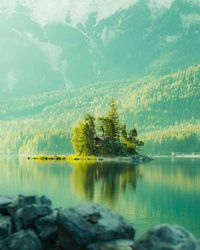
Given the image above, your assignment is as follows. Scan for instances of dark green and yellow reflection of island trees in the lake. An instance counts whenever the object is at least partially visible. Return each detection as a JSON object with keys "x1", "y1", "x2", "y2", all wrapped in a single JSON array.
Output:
[{"x1": 71, "y1": 162, "x2": 142, "y2": 208}]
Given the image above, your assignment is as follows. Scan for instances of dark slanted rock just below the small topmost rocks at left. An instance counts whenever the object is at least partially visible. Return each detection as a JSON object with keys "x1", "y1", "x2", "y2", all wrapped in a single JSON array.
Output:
[{"x1": 15, "y1": 205, "x2": 52, "y2": 230}]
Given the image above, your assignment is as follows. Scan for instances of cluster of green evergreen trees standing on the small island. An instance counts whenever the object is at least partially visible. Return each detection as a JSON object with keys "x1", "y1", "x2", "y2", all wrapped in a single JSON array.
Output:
[{"x1": 72, "y1": 99, "x2": 144, "y2": 156}]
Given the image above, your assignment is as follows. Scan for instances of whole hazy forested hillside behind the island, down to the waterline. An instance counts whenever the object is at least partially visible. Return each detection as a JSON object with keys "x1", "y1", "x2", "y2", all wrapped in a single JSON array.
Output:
[{"x1": 0, "y1": 65, "x2": 200, "y2": 153}]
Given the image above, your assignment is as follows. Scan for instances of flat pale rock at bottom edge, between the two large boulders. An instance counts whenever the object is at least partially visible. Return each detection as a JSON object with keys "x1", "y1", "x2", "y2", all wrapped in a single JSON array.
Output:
[{"x1": 86, "y1": 240, "x2": 135, "y2": 250}]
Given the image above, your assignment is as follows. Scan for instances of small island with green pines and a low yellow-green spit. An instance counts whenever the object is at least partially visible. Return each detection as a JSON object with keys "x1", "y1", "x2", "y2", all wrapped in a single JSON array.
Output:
[{"x1": 28, "y1": 99, "x2": 150, "y2": 163}]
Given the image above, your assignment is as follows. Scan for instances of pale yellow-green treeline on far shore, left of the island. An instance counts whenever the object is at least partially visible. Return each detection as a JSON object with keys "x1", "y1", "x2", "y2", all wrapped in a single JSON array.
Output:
[{"x1": 0, "y1": 130, "x2": 73, "y2": 154}]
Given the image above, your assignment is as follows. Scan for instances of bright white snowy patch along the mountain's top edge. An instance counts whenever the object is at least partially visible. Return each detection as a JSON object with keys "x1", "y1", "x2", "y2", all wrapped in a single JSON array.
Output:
[{"x1": 0, "y1": 0, "x2": 139, "y2": 26}]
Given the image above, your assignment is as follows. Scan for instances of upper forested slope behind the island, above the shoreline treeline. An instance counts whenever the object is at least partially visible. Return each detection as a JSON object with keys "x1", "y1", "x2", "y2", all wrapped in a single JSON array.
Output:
[{"x1": 0, "y1": 65, "x2": 200, "y2": 129}]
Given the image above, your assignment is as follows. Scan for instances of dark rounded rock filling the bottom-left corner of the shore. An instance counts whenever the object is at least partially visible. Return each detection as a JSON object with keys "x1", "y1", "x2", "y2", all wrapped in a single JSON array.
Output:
[{"x1": 0, "y1": 230, "x2": 42, "y2": 250}]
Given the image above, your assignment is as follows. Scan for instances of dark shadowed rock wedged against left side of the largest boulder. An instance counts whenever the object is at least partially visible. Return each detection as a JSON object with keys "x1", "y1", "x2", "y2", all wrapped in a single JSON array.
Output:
[{"x1": 34, "y1": 212, "x2": 58, "y2": 246}]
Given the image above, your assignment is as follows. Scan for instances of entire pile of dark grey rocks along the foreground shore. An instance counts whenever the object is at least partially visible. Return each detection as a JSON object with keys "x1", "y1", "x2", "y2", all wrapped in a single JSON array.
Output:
[{"x1": 0, "y1": 195, "x2": 200, "y2": 250}]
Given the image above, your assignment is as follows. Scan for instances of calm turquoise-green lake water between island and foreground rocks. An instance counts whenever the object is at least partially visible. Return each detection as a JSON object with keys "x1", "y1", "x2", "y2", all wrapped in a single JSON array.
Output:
[{"x1": 0, "y1": 157, "x2": 200, "y2": 238}]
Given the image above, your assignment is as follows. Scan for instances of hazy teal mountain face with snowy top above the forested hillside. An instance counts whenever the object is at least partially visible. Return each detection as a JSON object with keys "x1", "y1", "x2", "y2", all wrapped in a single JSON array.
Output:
[{"x1": 0, "y1": 0, "x2": 200, "y2": 100}]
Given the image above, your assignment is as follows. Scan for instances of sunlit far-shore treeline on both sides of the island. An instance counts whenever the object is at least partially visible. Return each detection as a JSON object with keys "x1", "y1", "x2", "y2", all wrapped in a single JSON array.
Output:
[{"x1": 0, "y1": 124, "x2": 200, "y2": 155}]
